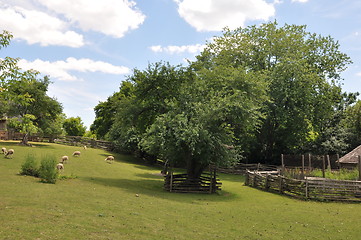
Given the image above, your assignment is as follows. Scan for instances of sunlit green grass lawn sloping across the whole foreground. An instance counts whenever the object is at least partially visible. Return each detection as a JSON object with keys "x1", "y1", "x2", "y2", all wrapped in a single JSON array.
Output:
[{"x1": 0, "y1": 141, "x2": 361, "y2": 240}]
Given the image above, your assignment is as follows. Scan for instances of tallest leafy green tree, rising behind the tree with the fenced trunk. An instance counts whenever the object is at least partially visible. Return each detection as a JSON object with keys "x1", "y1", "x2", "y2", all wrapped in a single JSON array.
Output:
[{"x1": 196, "y1": 22, "x2": 351, "y2": 161}]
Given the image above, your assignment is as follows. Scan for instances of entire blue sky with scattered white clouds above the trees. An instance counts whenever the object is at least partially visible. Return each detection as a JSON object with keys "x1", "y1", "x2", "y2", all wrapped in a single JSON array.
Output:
[{"x1": 0, "y1": 0, "x2": 361, "y2": 126}]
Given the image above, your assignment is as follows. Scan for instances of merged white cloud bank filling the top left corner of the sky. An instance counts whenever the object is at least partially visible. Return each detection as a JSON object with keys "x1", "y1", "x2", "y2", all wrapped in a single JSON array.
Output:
[{"x1": 0, "y1": 0, "x2": 145, "y2": 47}]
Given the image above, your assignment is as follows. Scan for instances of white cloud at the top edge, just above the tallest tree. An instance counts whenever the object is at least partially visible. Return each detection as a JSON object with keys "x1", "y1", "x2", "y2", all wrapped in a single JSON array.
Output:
[{"x1": 175, "y1": 0, "x2": 276, "y2": 31}]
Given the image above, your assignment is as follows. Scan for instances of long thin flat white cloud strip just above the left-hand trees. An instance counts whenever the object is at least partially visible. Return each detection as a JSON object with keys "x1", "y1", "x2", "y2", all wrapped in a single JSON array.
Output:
[{"x1": 18, "y1": 57, "x2": 130, "y2": 81}]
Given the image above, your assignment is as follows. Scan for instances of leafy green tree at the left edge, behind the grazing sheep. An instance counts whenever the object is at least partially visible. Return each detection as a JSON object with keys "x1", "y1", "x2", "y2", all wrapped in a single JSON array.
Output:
[{"x1": 0, "y1": 31, "x2": 62, "y2": 144}]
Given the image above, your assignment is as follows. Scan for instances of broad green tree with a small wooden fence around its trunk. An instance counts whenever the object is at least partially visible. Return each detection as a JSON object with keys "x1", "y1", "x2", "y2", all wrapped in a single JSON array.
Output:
[{"x1": 110, "y1": 63, "x2": 267, "y2": 178}]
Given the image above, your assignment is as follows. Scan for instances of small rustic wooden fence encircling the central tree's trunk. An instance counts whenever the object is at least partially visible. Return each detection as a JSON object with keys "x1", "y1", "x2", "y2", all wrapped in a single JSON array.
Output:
[{"x1": 164, "y1": 171, "x2": 222, "y2": 193}]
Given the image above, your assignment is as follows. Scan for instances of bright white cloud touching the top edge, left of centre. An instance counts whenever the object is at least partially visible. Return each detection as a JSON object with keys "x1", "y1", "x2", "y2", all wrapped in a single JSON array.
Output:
[{"x1": 37, "y1": 0, "x2": 145, "y2": 38}]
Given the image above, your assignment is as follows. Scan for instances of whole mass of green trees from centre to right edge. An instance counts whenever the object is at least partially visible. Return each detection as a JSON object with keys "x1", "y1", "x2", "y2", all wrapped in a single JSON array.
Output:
[{"x1": 91, "y1": 22, "x2": 361, "y2": 172}]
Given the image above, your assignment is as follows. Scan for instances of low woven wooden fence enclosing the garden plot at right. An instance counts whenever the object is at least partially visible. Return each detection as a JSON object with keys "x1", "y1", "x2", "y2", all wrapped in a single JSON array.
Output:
[{"x1": 245, "y1": 171, "x2": 361, "y2": 202}]
